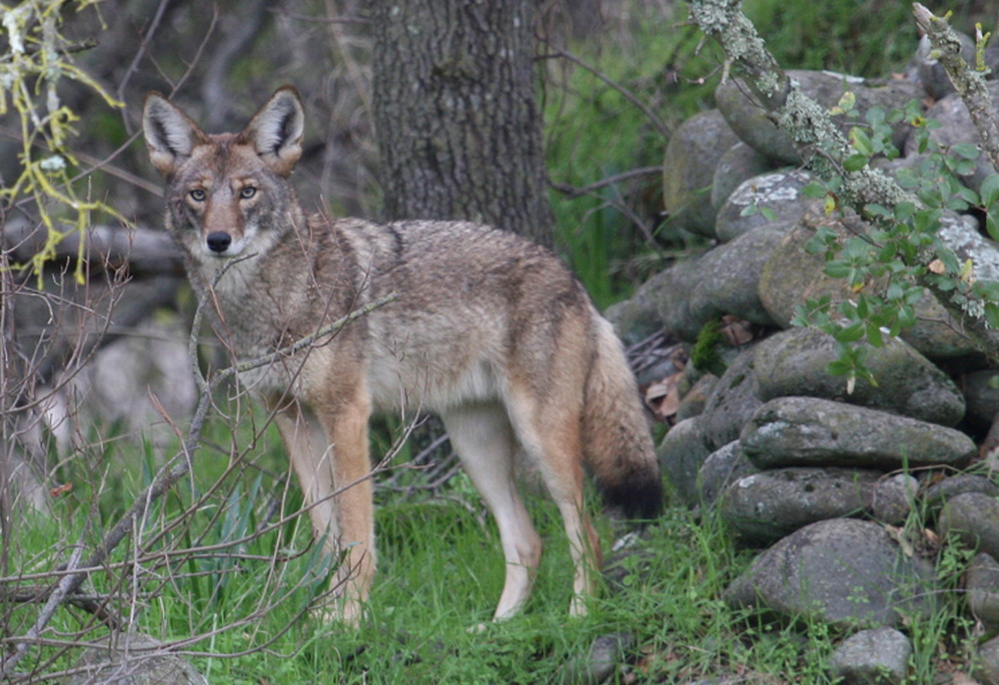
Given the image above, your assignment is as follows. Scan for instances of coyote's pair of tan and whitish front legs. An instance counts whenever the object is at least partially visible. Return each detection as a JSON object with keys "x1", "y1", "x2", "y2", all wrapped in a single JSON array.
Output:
[{"x1": 276, "y1": 388, "x2": 375, "y2": 624}]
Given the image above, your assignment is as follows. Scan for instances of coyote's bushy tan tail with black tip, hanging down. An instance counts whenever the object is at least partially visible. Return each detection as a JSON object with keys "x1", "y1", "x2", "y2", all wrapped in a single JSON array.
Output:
[{"x1": 583, "y1": 316, "x2": 663, "y2": 520}]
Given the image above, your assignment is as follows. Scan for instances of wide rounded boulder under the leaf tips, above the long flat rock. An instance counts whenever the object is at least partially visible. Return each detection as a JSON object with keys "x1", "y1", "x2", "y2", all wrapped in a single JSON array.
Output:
[{"x1": 754, "y1": 328, "x2": 964, "y2": 426}]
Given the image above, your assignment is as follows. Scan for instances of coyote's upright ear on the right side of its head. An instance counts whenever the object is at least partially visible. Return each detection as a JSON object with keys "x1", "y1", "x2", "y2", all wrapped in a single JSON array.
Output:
[{"x1": 240, "y1": 86, "x2": 305, "y2": 176}]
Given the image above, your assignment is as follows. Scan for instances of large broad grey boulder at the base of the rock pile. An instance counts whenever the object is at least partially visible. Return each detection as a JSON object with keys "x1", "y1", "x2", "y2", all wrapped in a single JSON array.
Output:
[{"x1": 723, "y1": 519, "x2": 935, "y2": 628}]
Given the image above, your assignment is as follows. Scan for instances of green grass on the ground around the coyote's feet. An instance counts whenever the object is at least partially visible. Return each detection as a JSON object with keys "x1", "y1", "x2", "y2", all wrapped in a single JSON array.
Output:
[{"x1": 2, "y1": 408, "x2": 984, "y2": 685}]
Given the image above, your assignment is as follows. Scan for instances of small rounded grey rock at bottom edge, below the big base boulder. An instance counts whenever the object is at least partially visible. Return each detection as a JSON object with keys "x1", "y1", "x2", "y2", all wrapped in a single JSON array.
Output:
[{"x1": 829, "y1": 628, "x2": 912, "y2": 685}]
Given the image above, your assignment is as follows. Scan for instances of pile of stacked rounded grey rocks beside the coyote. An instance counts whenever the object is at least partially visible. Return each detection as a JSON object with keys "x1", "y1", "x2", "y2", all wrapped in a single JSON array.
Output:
[{"x1": 608, "y1": 33, "x2": 999, "y2": 683}]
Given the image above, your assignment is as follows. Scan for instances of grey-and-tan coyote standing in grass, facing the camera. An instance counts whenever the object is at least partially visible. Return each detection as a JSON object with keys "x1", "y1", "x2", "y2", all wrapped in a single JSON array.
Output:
[{"x1": 142, "y1": 87, "x2": 662, "y2": 623}]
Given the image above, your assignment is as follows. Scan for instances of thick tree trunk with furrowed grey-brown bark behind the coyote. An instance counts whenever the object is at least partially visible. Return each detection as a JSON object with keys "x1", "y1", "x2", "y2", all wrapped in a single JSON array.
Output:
[{"x1": 374, "y1": 0, "x2": 552, "y2": 246}]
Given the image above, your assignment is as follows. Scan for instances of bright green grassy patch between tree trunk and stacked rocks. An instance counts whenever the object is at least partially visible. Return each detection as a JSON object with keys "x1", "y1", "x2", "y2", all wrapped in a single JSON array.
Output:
[{"x1": 543, "y1": 8, "x2": 719, "y2": 308}]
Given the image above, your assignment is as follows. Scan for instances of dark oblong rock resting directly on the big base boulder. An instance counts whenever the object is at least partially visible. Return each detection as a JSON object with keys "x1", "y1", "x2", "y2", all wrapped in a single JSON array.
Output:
[{"x1": 720, "y1": 468, "x2": 881, "y2": 544}]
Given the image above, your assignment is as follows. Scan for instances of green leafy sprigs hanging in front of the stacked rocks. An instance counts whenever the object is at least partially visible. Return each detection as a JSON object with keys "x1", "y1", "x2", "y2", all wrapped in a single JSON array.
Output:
[{"x1": 793, "y1": 91, "x2": 999, "y2": 388}]
